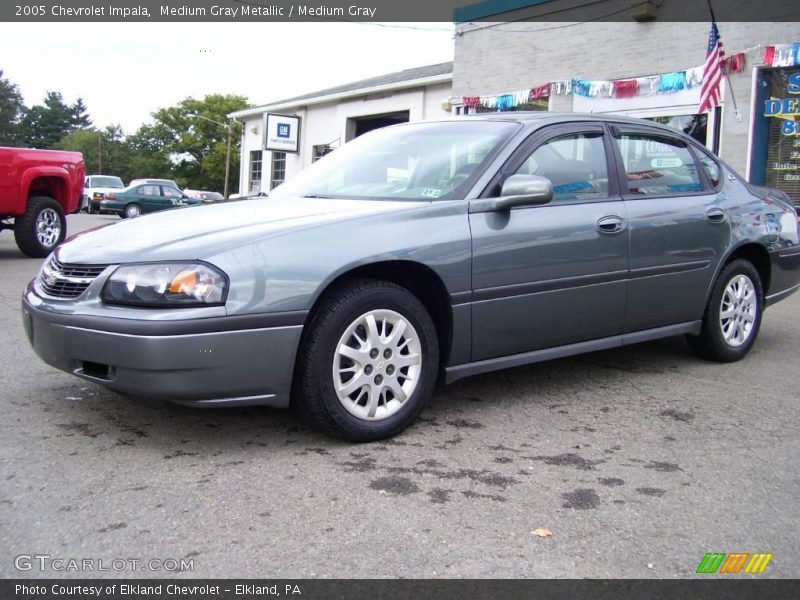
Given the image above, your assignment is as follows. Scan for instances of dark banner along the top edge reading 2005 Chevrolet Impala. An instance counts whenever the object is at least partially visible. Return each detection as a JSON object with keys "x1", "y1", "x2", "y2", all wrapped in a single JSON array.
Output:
[{"x1": 0, "y1": 0, "x2": 798, "y2": 23}]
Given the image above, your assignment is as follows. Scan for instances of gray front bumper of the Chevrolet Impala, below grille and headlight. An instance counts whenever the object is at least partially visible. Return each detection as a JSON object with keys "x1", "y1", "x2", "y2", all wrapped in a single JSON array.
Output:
[{"x1": 22, "y1": 288, "x2": 304, "y2": 407}]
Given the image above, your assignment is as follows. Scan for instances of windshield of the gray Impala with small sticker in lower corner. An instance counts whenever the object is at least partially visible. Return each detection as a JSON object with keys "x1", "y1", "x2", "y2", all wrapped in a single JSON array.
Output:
[{"x1": 270, "y1": 121, "x2": 518, "y2": 200}]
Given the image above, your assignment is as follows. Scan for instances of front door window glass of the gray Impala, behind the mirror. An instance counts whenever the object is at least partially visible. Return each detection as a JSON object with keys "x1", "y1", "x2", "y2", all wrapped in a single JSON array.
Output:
[{"x1": 516, "y1": 133, "x2": 608, "y2": 202}]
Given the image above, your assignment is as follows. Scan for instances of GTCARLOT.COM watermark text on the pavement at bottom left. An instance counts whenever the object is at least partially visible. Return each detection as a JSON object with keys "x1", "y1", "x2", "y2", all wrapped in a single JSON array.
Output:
[{"x1": 14, "y1": 554, "x2": 194, "y2": 573}]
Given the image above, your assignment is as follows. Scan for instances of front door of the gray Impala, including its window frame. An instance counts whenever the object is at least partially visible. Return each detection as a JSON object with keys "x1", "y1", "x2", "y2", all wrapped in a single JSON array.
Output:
[{"x1": 470, "y1": 123, "x2": 628, "y2": 361}]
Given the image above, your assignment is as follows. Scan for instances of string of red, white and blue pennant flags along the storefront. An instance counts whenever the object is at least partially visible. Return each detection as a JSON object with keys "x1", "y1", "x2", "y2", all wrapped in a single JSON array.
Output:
[{"x1": 461, "y1": 42, "x2": 800, "y2": 111}]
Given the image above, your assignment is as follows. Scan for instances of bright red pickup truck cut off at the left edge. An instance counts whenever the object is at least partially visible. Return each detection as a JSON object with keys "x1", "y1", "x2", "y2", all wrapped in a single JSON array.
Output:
[{"x1": 0, "y1": 147, "x2": 85, "y2": 258}]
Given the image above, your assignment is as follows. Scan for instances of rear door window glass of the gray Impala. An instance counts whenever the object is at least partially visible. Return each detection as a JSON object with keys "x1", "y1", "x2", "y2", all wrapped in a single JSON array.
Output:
[{"x1": 615, "y1": 134, "x2": 703, "y2": 196}]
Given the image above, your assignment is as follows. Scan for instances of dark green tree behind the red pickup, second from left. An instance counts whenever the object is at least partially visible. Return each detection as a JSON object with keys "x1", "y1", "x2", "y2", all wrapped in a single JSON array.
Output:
[{"x1": 21, "y1": 92, "x2": 92, "y2": 148}]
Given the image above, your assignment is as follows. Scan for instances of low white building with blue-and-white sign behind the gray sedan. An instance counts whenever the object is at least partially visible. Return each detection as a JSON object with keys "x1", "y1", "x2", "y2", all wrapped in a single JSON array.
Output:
[{"x1": 230, "y1": 62, "x2": 453, "y2": 194}]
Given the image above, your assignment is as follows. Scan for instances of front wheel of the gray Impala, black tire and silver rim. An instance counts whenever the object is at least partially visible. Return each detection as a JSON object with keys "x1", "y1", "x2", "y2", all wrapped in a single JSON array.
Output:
[{"x1": 292, "y1": 279, "x2": 439, "y2": 442}]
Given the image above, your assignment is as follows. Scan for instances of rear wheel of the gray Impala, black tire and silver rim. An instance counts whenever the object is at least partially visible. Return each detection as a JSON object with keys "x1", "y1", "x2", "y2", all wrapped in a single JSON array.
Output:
[{"x1": 687, "y1": 258, "x2": 764, "y2": 362}]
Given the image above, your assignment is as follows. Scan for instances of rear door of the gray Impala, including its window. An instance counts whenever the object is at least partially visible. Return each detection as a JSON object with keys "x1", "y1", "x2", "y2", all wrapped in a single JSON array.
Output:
[{"x1": 611, "y1": 125, "x2": 731, "y2": 332}]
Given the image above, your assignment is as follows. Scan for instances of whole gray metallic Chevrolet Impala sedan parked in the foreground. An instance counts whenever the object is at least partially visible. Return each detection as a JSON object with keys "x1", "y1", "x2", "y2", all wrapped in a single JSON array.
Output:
[{"x1": 23, "y1": 113, "x2": 800, "y2": 440}]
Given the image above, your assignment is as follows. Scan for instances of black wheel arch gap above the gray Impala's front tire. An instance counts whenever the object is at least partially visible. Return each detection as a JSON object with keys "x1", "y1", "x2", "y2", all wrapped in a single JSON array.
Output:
[{"x1": 300, "y1": 260, "x2": 453, "y2": 365}]
